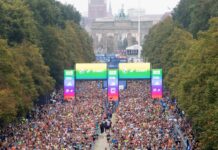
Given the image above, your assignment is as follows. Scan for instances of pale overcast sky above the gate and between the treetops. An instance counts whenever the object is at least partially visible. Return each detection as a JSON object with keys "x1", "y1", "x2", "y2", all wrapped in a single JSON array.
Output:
[{"x1": 58, "y1": 0, "x2": 180, "y2": 15}]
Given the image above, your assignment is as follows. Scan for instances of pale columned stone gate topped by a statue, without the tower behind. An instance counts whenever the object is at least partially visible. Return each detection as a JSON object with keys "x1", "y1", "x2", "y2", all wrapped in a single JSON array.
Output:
[{"x1": 91, "y1": 13, "x2": 161, "y2": 54}]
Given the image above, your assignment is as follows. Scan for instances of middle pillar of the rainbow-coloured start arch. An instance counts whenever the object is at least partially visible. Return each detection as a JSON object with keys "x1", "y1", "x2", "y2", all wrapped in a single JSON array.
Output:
[{"x1": 107, "y1": 70, "x2": 119, "y2": 101}]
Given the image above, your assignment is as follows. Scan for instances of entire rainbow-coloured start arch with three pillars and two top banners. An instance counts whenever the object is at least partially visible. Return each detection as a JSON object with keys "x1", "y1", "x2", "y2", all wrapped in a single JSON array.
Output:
[{"x1": 64, "y1": 63, "x2": 163, "y2": 101}]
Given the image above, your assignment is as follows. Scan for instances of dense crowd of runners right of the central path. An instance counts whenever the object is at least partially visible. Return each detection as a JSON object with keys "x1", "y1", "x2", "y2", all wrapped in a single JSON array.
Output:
[{"x1": 111, "y1": 81, "x2": 194, "y2": 150}]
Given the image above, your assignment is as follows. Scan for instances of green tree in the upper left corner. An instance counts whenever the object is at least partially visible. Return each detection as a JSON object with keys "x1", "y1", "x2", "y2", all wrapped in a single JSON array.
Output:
[{"x1": 0, "y1": 0, "x2": 37, "y2": 44}]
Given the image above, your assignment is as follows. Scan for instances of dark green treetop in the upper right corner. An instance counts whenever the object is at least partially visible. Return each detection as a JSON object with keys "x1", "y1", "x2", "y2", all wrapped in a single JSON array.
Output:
[{"x1": 173, "y1": 0, "x2": 218, "y2": 38}]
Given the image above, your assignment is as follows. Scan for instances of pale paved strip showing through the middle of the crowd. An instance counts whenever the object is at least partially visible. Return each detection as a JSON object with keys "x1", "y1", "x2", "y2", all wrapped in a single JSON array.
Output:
[{"x1": 95, "y1": 114, "x2": 116, "y2": 150}]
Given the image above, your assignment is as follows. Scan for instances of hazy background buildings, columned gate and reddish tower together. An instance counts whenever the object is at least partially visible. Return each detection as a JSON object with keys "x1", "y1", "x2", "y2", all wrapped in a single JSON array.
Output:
[{"x1": 87, "y1": 0, "x2": 161, "y2": 54}]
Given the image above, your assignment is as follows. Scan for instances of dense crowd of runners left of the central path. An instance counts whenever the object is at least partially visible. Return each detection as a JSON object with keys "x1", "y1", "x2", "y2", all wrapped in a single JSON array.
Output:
[{"x1": 0, "y1": 81, "x2": 107, "y2": 150}]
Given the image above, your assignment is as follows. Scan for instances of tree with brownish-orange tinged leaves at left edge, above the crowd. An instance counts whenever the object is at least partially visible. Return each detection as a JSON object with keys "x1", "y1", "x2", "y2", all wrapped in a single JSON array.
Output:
[{"x1": 0, "y1": 40, "x2": 54, "y2": 124}]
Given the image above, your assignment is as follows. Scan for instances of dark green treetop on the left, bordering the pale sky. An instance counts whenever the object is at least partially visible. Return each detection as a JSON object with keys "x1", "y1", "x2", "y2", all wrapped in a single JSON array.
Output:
[{"x1": 25, "y1": 0, "x2": 81, "y2": 28}]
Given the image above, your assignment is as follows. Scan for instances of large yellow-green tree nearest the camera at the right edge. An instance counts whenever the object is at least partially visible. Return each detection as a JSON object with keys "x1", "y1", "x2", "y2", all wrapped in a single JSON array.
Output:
[{"x1": 177, "y1": 18, "x2": 218, "y2": 149}]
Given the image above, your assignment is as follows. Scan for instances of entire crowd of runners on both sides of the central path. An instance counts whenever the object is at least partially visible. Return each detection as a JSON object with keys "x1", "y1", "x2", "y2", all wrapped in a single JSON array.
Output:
[{"x1": 0, "y1": 81, "x2": 196, "y2": 150}]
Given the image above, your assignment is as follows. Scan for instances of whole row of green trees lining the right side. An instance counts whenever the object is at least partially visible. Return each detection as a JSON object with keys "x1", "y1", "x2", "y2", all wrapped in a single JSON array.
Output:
[{"x1": 143, "y1": 0, "x2": 218, "y2": 150}]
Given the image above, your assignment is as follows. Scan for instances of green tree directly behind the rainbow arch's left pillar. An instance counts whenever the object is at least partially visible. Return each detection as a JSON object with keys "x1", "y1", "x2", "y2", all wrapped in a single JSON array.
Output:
[{"x1": 41, "y1": 22, "x2": 94, "y2": 86}]
